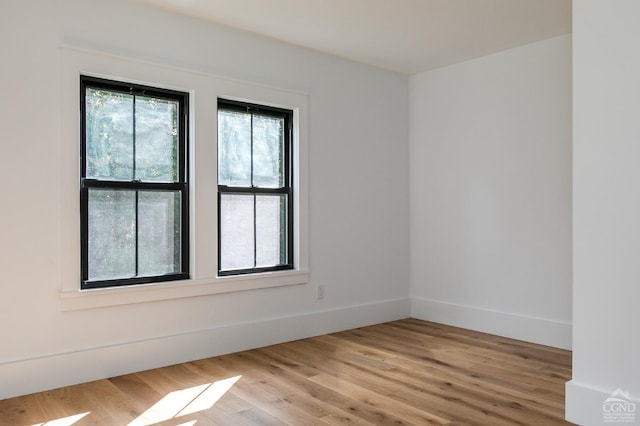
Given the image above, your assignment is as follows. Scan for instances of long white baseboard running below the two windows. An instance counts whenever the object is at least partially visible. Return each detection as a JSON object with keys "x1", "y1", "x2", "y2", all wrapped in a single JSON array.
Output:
[{"x1": 0, "y1": 298, "x2": 410, "y2": 399}]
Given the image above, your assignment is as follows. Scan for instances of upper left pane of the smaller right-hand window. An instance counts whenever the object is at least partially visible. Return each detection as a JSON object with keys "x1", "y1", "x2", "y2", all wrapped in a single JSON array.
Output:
[{"x1": 218, "y1": 110, "x2": 251, "y2": 187}]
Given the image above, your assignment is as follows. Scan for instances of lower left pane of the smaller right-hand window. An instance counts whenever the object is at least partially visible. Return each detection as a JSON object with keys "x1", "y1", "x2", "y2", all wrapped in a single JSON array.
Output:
[{"x1": 220, "y1": 194, "x2": 254, "y2": 270}]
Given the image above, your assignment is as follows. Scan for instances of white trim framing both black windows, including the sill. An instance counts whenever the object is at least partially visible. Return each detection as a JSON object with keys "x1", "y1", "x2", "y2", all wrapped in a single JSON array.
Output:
[{"x1": 59, "y1": 46, "x2": 309, "y2": 311}]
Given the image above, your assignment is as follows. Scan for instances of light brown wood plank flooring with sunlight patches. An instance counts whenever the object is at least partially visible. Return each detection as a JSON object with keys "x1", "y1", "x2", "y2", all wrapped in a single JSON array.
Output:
[{"x1": 0, "y1": 319, "x2": 571, "y2": 426}]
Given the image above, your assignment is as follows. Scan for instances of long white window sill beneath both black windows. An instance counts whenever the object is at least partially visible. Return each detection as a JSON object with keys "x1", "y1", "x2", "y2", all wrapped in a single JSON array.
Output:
[{"x1": 60, "y1": 270, "x2": 309, "y2": 311}]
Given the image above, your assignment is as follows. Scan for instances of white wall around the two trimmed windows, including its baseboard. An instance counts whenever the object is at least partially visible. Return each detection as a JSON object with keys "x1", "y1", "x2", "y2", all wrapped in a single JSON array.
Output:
[{"x1": 0, "y1": 0, "x2": 409, "y2": 398}]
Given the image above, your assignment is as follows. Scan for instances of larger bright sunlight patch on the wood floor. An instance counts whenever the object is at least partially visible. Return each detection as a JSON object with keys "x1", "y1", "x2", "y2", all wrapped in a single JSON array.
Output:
[{"x1": 128, "y1": 376, "x2": 242, "y2": 426}]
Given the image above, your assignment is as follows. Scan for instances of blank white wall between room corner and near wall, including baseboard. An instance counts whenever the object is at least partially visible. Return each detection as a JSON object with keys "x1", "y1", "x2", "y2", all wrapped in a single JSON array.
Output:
[{"x1": 410, "y1": 35, "x2": 571, "y2": 348}]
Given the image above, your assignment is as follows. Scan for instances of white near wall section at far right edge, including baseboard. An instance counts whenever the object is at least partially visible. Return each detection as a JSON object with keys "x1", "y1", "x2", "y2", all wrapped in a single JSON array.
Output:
[{"x1": 567, "y1": 0, "x2": 640, "y2": 425}]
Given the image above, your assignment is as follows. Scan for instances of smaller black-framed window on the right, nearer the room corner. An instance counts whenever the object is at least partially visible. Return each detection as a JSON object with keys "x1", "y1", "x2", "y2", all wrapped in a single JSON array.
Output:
[{"x1": 218, "y1": 99, "x2": 293, "y2": 276}]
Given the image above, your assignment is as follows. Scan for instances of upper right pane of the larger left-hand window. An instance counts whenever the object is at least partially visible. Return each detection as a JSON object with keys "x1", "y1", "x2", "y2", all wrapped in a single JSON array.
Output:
[{"x1": 135, "y1": 96, "x2": 178, "y2": 182}]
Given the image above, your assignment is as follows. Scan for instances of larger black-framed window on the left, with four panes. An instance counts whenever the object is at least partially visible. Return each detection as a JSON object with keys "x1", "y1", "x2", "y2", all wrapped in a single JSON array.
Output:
[{"x1": 80, "y1": 76, "x2": 189, "y2": 289}]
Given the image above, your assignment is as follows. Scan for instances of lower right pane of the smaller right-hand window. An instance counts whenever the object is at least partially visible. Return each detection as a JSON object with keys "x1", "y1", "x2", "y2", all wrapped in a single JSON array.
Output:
[{"x1": 256, "y1": 195, "x2": 287, "y2": 267}]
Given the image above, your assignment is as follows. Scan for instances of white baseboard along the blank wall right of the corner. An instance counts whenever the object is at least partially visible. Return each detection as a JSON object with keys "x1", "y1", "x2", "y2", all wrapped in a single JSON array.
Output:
[{"x1": 411, "y1": 297, "x2": 572, "y2": 349}]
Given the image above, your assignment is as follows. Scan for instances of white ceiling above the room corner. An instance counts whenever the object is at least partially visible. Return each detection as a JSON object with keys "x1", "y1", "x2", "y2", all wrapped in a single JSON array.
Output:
[{"x1": 137, "y1": 0, "x2": 571, "y2": 75}]
